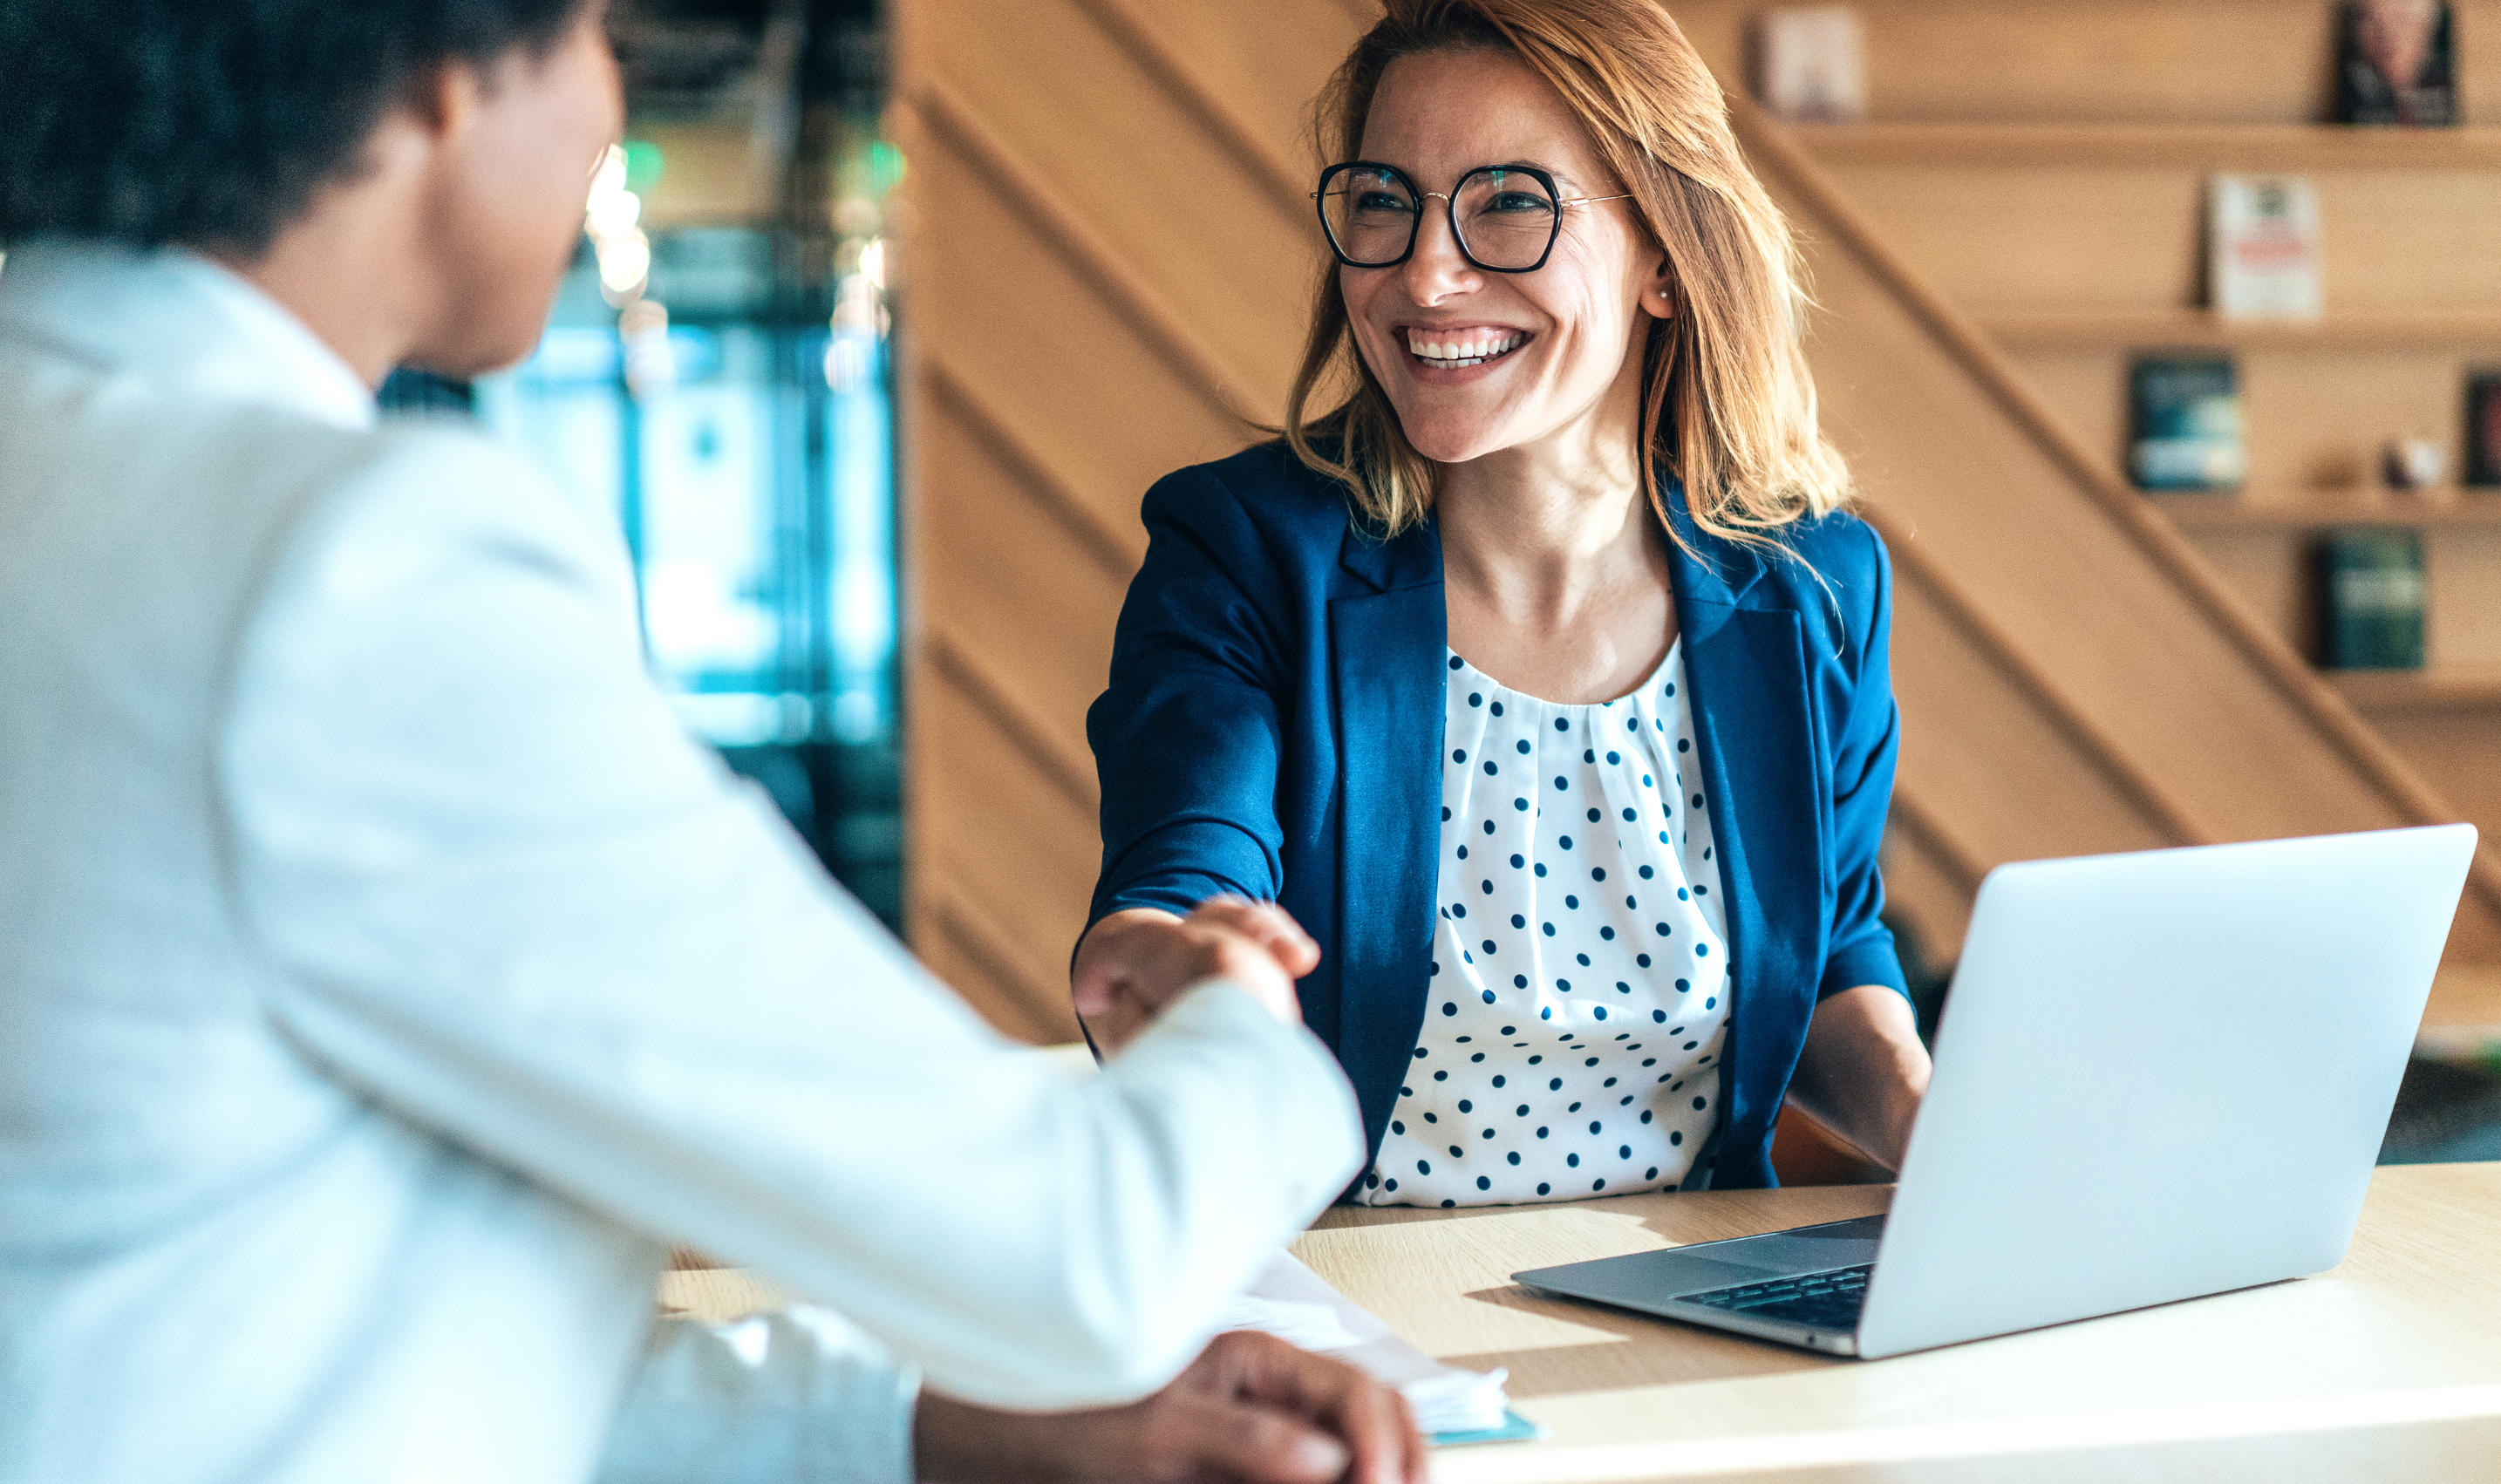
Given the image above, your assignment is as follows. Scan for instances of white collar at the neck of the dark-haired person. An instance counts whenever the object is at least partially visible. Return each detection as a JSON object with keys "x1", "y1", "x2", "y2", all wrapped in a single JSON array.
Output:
[{"x1": 0, "y1": 241, "x2": 375, "y2": 428}]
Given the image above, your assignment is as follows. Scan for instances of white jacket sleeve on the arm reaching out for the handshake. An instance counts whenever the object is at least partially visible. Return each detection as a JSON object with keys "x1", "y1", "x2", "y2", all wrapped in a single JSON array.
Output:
[{"x1": 218, "y1": 431, "x2": 1363, "y2": 1406}]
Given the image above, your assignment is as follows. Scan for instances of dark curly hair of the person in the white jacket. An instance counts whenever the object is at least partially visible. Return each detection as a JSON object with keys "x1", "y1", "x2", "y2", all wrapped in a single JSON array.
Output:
[{"x1": 0, "y1": 0, "x2": 597, "y2": 255}]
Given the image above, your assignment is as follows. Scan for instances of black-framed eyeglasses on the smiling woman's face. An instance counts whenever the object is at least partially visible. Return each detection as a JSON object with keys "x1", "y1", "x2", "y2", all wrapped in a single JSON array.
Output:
[{"x1": 1311, "y1": 160, "x2": 1631, "y2": 273}]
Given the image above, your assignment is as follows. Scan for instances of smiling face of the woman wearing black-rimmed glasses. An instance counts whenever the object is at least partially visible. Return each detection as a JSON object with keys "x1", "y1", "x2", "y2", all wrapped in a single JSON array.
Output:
[{"x1": 1338, "y1": 50, "x2": 1668, "y2": 463}]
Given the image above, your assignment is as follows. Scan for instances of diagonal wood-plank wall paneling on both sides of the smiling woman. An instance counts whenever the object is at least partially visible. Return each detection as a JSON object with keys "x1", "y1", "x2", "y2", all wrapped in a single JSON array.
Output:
[{"x1": 896, "y1": 0, "x2": 2501, "y2": 1038}]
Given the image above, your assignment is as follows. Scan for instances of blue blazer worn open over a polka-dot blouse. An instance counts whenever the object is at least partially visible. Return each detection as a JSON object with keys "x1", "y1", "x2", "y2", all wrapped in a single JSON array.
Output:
[{"x1": 1086, "y1": 443, "x2": 1904, "y2": 1186}]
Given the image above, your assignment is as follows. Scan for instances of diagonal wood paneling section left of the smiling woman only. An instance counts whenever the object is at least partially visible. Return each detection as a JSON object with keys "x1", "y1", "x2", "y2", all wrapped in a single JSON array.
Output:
[{"x1": 893, "y1": 0, "x2": 1360, "y2": 1041}]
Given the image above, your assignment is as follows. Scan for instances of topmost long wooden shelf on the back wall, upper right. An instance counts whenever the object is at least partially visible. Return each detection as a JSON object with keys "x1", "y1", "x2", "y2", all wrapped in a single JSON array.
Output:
[{"x1": 1793, "y1": 123, "x2": 2501, "y2": 170}]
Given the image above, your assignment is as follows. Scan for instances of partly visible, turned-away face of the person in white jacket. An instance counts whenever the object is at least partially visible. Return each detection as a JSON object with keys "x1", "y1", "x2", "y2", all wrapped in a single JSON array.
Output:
[{"x1": 410, "y1": 0, "x2": 625, "y2": 376}]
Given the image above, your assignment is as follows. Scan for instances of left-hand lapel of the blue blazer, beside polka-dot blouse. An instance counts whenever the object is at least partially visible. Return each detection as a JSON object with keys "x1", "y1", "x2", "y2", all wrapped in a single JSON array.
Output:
[{"x1": 1316, "y1": 523, "x2": 1448, "y2": 1148}]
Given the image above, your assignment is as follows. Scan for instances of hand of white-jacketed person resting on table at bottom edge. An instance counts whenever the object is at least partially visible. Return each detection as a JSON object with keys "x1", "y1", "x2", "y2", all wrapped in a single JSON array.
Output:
[{"x1": 913, "y1": 1321, "x2": 1423, "y2": 1484}]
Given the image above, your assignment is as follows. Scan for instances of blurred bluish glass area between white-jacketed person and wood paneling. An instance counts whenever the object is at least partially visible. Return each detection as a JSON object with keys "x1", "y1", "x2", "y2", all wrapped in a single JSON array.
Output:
[{"x1": 383, "y1": 0, "x2": 903, "y2": 929}]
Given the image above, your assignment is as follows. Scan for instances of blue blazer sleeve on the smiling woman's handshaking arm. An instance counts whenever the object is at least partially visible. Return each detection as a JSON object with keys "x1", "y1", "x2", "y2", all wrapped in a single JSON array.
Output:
[{"x1": 1086, "y1": 468, "x2": 1283, "y2": 926}]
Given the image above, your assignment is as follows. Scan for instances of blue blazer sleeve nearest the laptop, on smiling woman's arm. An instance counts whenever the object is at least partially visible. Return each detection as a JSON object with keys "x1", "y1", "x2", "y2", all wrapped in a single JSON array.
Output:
[{"x1": 1816, "y1": 521, "x2": 1911, "y2": 998}]
